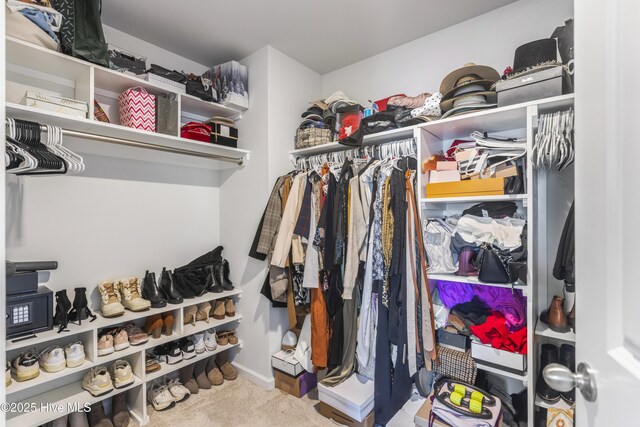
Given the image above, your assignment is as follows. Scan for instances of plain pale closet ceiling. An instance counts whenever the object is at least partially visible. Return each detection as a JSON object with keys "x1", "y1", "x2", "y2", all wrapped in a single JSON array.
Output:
[{"x1": 102, "y1": 0, "x2": 515, "y2": 74}]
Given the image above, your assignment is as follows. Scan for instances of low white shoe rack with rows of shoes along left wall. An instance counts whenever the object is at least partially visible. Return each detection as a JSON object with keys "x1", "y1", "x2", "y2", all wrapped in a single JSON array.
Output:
[{"x1": 5, "y1": 289, "x2": 242, "y2": 427}]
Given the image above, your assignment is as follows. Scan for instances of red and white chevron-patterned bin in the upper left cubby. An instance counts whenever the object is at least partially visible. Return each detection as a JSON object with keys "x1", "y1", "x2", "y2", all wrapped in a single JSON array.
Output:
[{"x1": 118, "y1": 87, "x2": 156, "y2": 132}]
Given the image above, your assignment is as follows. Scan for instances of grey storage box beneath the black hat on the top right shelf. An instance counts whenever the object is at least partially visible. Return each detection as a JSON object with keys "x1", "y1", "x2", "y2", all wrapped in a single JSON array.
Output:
[{"x1": 496, "y1": 65, "x2": 573, "y2": 107}]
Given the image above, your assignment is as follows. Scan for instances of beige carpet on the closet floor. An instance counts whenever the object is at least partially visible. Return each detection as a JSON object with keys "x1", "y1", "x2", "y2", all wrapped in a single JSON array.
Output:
[{"x1": 147, "y1": 377, "x2": 335, "y2": 427}]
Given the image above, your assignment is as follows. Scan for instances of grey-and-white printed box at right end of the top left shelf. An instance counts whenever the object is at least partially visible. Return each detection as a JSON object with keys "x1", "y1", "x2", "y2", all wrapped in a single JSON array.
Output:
[{"x1": 202, "y1": 61, "x2": 249, "y2": 110}]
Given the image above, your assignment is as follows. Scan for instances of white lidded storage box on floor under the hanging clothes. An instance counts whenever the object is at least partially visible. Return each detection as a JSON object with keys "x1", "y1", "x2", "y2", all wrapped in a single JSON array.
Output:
[{"x1": 318, "y1": 374, "x2": 374, "y2": 421}]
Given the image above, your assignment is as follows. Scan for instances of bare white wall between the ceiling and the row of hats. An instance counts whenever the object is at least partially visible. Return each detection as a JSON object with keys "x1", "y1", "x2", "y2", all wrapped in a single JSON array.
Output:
[{"x1": 322, "y1": 0, "x2": 573, "y2": 105}]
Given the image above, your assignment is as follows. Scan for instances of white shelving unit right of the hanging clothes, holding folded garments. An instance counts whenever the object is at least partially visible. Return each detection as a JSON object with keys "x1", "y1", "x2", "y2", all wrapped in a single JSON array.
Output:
[{"x1": 289, "y1": 94, "x2": 575, "y2": 425}]
